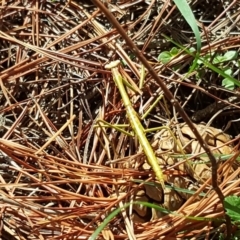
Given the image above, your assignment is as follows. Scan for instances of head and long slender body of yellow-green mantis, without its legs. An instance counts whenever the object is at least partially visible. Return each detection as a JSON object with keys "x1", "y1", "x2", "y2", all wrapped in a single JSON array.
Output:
[{"x1": 105, "y1": 60, "x2": 165, "y2": 189}]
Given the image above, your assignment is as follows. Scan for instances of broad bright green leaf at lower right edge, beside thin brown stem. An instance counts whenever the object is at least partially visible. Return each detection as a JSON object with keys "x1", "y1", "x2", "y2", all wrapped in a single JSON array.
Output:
[{"x1": 223, "y1": 196, "x2": 240, "y2": 222}]
